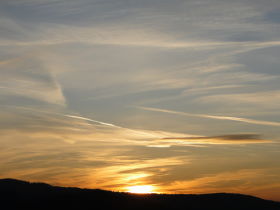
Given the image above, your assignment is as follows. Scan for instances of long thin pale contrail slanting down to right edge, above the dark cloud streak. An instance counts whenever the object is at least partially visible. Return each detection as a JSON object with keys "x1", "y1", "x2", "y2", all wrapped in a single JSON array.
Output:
[{"x1": 136, "y1": 106, "x2": 280, "y2": 126}]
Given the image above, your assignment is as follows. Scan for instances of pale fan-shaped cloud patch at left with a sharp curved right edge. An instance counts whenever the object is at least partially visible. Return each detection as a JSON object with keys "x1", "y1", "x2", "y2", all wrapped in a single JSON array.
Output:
[{"x1": 0, "y1": 55, "x2": 65, "y2": 105}]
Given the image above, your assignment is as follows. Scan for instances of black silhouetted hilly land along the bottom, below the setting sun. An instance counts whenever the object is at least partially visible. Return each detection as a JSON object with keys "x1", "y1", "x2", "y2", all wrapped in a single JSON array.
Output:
[{"x1": 0, "y1": 179, "x2": 280, "y2": 210}]
